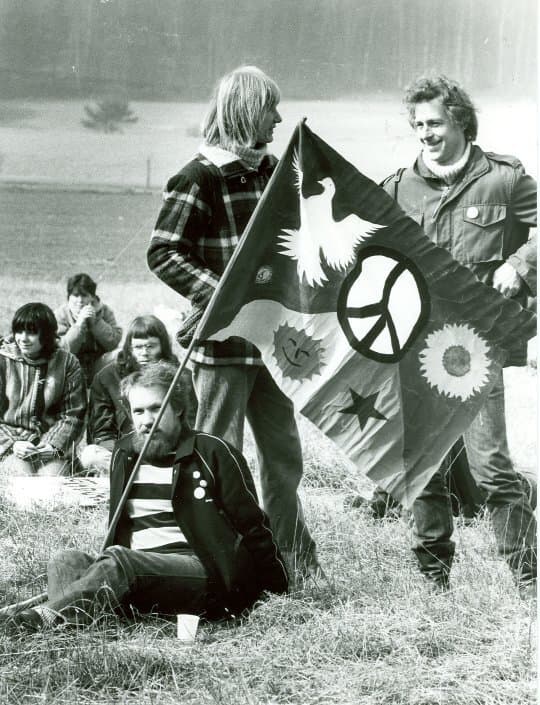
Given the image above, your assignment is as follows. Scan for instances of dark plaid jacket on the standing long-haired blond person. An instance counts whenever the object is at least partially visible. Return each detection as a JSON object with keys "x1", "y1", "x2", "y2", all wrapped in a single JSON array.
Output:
[{"x1": 148, "y1": 145, "x2": 277, "y2": 365}]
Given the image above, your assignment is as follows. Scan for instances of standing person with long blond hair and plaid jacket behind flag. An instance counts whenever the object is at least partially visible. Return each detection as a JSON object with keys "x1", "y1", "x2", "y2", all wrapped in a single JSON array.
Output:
[{"x1": 148, "y1": 66, "x2": 320, "y2": 578}]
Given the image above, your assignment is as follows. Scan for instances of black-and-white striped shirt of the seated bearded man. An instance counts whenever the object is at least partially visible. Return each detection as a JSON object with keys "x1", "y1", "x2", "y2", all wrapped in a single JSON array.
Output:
[{"x1": 126, "y1": 464, "x2": 188, "y2": 553}]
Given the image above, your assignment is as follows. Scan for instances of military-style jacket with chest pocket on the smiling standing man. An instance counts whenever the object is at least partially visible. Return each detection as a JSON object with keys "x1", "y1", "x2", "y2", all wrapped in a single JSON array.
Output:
[{"x1": 383, "y1": 145, "x2": 537, "y2": 365}]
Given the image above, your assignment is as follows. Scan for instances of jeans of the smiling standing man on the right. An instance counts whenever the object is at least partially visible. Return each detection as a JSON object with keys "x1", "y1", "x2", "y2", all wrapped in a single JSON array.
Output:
[{"x1": 412, "y1": 372, "x2": 536, "y2": 583}]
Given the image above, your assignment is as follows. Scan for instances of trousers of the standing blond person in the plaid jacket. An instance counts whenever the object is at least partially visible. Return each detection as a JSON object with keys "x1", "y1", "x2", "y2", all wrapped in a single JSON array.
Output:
[{"x1": 193, "y1": 363, "x2": 316, "y2": 568}]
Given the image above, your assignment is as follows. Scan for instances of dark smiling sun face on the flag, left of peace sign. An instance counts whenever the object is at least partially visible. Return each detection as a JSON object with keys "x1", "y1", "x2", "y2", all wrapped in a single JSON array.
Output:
[{"x1": 273, "y1": 323, "x2": 324, "y2": 380}]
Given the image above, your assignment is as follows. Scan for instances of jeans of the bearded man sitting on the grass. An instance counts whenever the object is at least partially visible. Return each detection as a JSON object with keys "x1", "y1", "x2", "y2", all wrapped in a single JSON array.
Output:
[{"x1": 44, "y1": 546, "x2": 207, "y2": 623}]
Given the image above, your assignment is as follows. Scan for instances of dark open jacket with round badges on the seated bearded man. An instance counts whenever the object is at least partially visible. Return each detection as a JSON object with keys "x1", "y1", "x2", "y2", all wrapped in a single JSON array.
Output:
[{"x1": 109, "y1": 431, "x2": 288, "y2": 617}]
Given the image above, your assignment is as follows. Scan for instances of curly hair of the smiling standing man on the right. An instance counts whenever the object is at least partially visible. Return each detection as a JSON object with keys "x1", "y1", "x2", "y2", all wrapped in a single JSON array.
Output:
[{"x1": 403, "y1": 76, "x2": 478, "y2": 142}]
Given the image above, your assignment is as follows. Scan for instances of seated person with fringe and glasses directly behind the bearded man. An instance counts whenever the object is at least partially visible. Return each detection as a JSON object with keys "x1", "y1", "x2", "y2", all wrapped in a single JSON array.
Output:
[{"x1": 80, "y1": 315, "x2": 197, "y2": 475}]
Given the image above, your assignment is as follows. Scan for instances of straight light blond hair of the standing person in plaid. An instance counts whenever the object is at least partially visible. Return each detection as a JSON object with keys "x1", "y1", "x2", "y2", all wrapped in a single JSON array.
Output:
[{"x1": 202, "y1": 66, "x2": 280, "y2": 152}]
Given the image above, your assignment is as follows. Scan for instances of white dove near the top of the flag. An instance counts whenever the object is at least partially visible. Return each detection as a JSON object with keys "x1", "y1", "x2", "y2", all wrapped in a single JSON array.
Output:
[{"x1": 278, "y1": 151, "x2": 385, "y2": 286}]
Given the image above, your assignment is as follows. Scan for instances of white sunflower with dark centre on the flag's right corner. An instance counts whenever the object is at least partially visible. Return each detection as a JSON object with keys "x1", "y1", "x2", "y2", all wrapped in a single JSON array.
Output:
[{"x1": 420, "y1": 324, "x2": 490, "y2": 401}]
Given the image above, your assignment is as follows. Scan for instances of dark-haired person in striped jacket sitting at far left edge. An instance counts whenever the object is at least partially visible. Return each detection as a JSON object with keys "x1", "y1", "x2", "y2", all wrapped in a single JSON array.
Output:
[{"x1": 0, "y1": 303, "x2": 86, "y2": 475}]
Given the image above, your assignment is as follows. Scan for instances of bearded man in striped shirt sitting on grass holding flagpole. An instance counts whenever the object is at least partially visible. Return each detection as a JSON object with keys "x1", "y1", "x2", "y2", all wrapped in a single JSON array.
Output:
[{"x1": 0, "y1": 361, "x2": 288, "y2": 632}]
